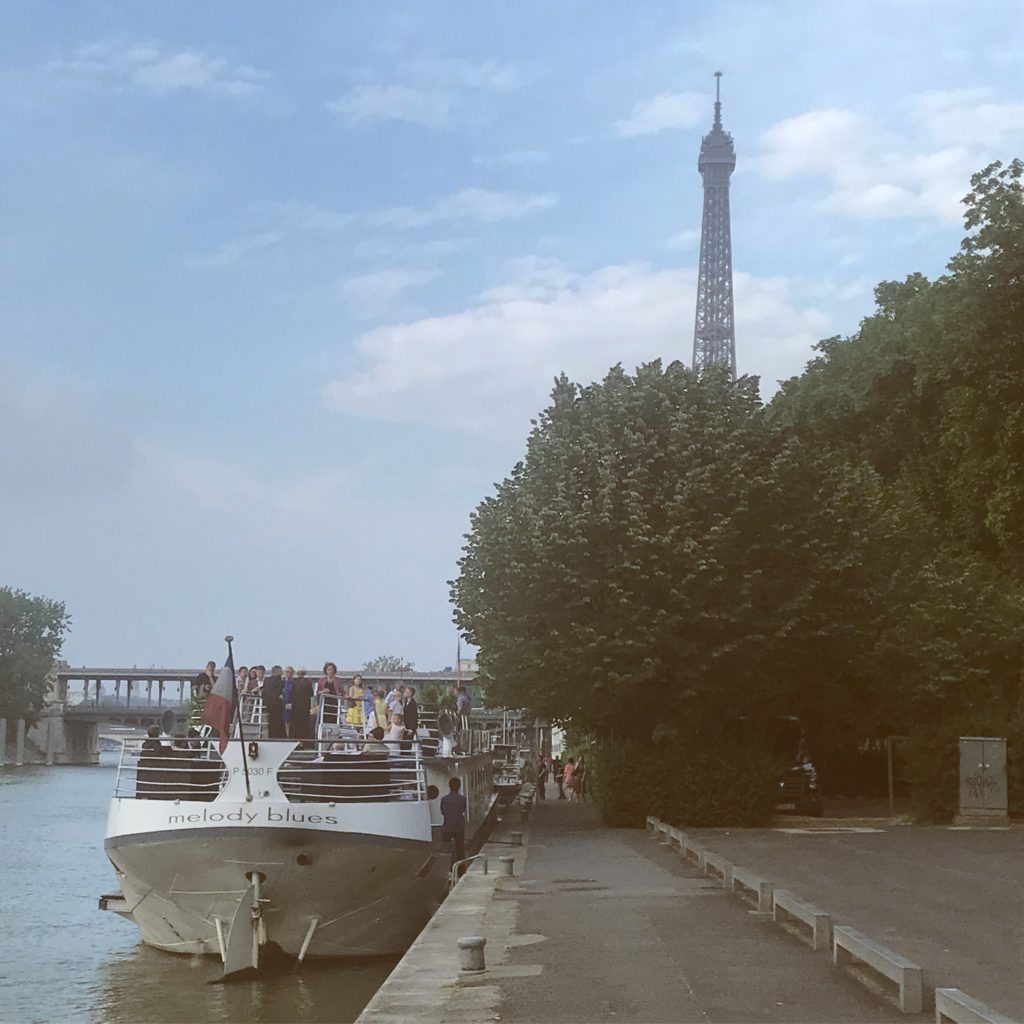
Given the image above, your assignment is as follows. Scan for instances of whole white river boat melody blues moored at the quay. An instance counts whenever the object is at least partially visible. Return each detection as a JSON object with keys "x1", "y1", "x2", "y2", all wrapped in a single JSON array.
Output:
[{"x1": 100, "y1": 695, "x2": 496, "y2": 974}]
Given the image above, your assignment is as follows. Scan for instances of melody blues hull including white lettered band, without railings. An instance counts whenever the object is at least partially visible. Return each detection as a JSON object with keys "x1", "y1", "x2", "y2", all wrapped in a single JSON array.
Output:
[{"x1": 100, "y1": 743, "x2": 495, "y2": 958}]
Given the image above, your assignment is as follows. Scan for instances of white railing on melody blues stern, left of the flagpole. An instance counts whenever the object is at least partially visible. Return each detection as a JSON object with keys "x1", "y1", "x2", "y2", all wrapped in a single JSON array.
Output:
[{"x1": 114, "y1": 737, "x2": 227, "y2": 802}]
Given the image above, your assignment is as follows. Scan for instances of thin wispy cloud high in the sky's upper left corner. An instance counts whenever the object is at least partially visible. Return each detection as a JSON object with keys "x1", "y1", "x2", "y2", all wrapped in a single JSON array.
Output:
[{"x1": 46, "y1": 39, "x2": 268, "y2": 96}]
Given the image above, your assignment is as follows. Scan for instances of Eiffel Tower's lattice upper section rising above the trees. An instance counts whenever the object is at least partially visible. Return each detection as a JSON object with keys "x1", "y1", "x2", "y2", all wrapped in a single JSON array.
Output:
[{"x1": 692, "y1": 71, "x2": 736, "y2": 379}]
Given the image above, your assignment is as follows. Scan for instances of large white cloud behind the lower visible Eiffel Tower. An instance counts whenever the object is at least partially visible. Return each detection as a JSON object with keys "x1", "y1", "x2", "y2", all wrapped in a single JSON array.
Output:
[{"x1": 325, "y1": 257, "x2": 830, "y2": 437}]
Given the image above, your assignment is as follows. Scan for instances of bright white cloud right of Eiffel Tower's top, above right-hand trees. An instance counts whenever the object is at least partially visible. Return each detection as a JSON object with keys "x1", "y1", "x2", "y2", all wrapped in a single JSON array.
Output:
[{"x1": 754, "y1": 89, "x2": 1024, "y2": 222}]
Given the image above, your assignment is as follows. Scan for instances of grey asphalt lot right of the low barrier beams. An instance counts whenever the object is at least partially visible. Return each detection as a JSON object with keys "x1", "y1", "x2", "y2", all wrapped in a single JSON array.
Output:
[{"x1": 687, "y1": 822, "x2": 1024, "y2": 1020}]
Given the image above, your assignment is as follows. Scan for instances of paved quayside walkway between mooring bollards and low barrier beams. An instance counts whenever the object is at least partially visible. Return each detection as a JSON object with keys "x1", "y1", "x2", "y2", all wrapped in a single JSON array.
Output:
[{"x1": 495, "y1": 802, "x2": 913, "y2": 1024}]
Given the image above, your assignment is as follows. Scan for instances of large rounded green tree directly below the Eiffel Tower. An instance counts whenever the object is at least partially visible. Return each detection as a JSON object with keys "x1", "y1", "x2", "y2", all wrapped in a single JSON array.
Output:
[{"x1": 452, "y1": 361, "x2": 892, "y2": 739}]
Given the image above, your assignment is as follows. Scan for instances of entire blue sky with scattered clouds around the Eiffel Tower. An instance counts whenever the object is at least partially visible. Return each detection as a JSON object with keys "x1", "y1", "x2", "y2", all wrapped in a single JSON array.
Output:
[{"x1": 0, "y1": 0, "x2": 1024, "y2": 669}]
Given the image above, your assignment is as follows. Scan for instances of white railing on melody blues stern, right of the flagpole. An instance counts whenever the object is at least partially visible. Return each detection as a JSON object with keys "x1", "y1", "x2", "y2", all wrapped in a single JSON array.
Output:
[{"x1": 278, "y1": 730, "x2": 427, "y2": 804}]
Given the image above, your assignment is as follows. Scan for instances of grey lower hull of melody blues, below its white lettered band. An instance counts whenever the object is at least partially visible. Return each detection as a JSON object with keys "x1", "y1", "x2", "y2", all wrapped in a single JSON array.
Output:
[{"x1": 106, "y1": 827, "x2": 447, "y2": 956}]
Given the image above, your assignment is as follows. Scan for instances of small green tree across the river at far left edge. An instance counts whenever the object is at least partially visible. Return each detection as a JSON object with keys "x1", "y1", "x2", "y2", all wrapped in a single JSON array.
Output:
[{"x1": 0, "y1": 587, "x2": 71, "y2": 721}]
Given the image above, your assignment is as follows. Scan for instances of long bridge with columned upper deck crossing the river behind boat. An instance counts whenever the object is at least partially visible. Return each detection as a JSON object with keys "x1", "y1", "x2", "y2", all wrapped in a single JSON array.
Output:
[{"x1": 0, "y1": 665, "x2": 478, "y2": 767}]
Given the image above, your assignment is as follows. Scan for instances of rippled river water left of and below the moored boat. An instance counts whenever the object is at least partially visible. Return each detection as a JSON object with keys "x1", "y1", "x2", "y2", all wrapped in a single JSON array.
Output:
[{"x1": 0, "y1": 754, "x2": 395, "y2": 1024}]
